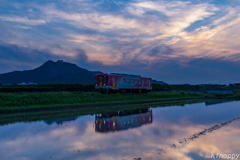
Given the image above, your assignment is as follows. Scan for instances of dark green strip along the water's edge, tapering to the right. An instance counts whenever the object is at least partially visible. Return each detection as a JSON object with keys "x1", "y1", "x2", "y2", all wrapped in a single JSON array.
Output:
[{"x1": 0, "y1": 100, "x2": 202, "y2": 126}]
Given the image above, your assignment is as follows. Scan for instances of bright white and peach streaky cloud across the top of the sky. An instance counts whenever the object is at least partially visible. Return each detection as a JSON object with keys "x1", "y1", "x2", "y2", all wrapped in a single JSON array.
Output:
[{"x1": 42, "y1": 2, "x2": 217, "y2": 35}]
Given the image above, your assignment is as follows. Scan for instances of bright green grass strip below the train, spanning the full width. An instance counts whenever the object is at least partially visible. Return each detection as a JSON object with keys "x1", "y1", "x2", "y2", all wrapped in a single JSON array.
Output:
[{"x1": 0, "y1": 91, "x2": 240, "y2": 111}]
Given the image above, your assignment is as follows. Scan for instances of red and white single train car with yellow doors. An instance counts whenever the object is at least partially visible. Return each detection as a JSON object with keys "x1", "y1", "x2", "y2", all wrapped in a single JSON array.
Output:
[{"x1": 95, "y1": 73, "x2": 152, "y2": 93}]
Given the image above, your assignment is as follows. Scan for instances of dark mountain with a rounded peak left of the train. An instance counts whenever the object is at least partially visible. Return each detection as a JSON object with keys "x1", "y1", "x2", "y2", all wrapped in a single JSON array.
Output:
[{"x1": 0, "y1": 60, "x2": 102, "y2": 84}]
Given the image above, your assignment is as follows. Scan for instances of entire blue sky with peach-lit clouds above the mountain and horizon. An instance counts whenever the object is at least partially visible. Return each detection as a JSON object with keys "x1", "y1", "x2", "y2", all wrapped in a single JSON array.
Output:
[{"x1": 0, "y1": 0, "x2": 240, "y2": 84}]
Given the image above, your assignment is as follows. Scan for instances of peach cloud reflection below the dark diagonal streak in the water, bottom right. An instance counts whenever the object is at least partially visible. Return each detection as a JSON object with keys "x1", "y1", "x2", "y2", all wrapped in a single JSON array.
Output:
[{"x1": 168, "y1": 121, "x2": 240, "y2": 158}]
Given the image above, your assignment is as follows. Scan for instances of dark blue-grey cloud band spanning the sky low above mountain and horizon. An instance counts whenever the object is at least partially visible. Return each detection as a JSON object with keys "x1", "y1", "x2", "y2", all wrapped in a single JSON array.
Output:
[{"x1": 0, "y1": 40, "x2": 240, "y2": 84}]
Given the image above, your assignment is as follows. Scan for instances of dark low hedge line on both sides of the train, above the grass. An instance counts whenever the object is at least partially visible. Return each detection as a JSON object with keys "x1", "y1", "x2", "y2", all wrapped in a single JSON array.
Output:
[{"x1": 0, "y1": 84, "x2": 237, "y2": 93}]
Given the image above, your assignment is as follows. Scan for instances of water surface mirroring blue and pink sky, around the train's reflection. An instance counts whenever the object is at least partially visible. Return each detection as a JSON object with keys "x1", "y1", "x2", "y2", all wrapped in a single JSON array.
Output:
[{"x1": 0, "y1": 102, "x2": 240, "y2": 160}]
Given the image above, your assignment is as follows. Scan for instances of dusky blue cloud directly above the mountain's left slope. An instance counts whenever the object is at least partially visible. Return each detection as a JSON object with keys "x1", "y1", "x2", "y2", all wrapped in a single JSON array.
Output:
[{"x1": 0, "y1": 42, "x2": 79, "y2": 73}]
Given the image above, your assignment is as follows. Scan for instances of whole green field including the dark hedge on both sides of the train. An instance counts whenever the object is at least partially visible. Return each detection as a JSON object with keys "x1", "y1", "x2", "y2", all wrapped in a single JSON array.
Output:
[{"x1": 0, "y1": 85, "x2": 240, "y2": 111}]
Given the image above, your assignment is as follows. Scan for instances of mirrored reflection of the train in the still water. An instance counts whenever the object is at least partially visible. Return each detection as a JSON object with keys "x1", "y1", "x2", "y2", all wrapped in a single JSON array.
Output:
[{"x1": 95, "y1": 109, "x2": 152, "y2": 133}]
